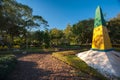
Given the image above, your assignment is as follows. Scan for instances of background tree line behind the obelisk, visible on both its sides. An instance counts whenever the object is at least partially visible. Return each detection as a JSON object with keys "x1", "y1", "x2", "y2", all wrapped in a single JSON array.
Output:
[{"x1": 23, "y1": 14, "x2": 120, "y2": 48}]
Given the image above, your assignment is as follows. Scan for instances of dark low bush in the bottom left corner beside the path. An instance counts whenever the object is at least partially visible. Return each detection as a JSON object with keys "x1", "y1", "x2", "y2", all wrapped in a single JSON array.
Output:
[{"x1": 0, "y1": 55, "x2": 17, "y2": 79}]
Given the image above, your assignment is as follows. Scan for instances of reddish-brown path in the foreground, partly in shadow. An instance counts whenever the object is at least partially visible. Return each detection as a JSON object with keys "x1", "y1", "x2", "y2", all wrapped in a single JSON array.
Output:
[{"x1": 8, "y1": 53, "x2": 92, "y2": 80}]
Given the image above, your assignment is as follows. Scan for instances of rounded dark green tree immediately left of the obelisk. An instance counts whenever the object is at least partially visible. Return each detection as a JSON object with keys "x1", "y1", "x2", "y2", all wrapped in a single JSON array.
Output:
[{"x1": 72, "y1": 19, "x2": 94, "y2": 44}]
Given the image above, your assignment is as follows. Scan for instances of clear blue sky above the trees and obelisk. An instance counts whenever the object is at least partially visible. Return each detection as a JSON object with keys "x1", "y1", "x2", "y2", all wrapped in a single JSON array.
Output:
[{"x1": 16, "y1": 0, "x2": 120, "y2": 29}]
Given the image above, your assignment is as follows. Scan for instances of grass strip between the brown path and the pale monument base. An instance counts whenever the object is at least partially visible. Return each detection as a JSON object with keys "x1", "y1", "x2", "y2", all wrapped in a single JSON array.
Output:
[{"x1": 52, "y1": 51, "x2": 107, "y2": 80}]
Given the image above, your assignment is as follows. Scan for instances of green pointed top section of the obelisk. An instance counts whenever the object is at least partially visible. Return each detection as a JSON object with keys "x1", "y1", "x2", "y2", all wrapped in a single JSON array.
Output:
[{"x1": 94, "y1": 6, "x2": 105, "y2": 28}]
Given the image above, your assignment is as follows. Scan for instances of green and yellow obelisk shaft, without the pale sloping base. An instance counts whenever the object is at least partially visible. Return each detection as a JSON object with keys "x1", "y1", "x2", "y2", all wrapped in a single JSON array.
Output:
[{"x1": 92, "y1": 6, "x2": 112, "y2": 51}]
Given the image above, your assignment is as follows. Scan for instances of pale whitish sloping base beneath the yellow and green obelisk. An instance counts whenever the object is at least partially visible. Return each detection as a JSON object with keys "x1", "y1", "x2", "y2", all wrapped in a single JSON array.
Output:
[{"x1": 77, "y1": 50, "x2": 120, "y2": 79}]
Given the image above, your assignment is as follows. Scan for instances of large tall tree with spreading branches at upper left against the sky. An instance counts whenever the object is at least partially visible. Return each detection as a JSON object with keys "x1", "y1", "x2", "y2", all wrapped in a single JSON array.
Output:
[{"x1": 0, "y1": 0, "x2": 48, "y2": 48}]
